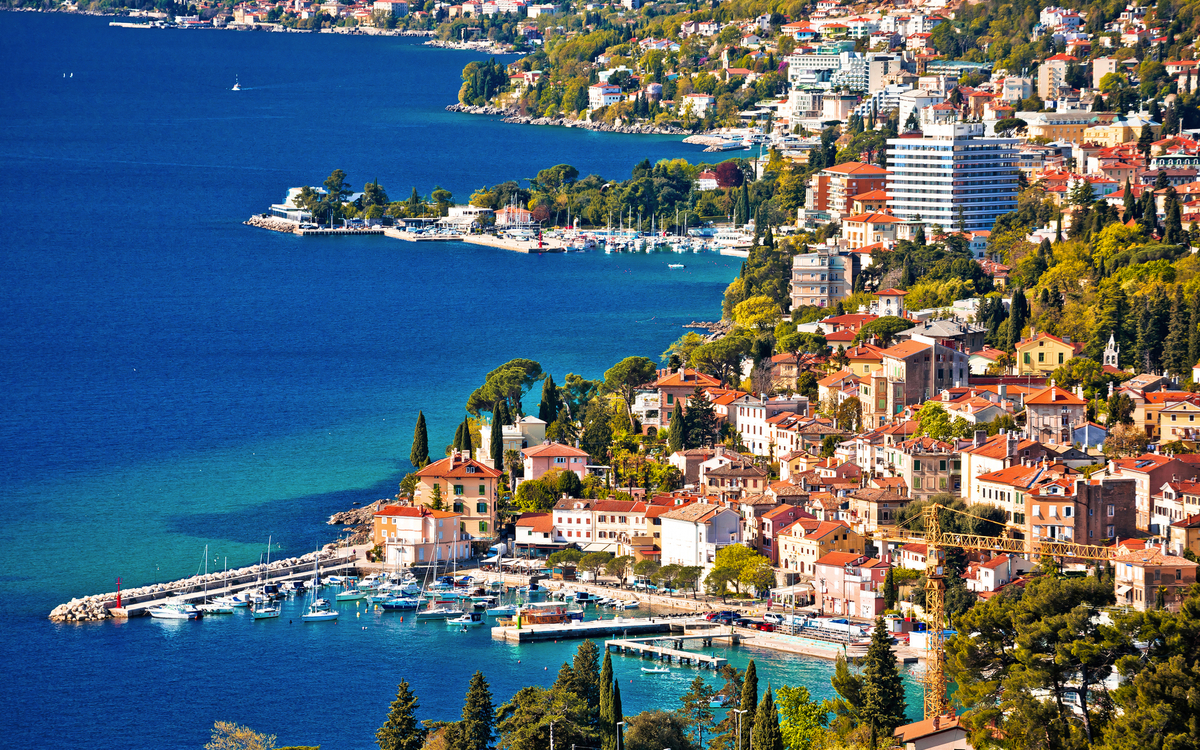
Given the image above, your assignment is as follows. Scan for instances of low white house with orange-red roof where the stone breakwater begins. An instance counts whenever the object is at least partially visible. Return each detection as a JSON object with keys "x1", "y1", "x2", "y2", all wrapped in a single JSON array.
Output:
[{"x1": 371, "y1": 505, "x2": 470, "y2": 566}]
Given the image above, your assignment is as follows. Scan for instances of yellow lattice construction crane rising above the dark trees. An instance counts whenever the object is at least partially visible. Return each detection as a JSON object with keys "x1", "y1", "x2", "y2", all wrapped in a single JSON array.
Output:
[{"x1": 874, "y1": 504, "x2": 1117, "y2": 719}]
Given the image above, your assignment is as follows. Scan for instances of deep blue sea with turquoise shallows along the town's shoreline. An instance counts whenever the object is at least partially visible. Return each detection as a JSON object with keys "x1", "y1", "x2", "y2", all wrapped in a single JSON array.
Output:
[{"x1": 0, "y1": 12, "x2": 919, "y2": 750}]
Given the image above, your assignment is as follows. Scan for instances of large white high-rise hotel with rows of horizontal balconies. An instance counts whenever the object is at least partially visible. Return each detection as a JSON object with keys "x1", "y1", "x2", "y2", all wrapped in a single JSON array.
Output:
[{"x1": 888, "y1": 104, "x2": 1018, "y2": 232}]
